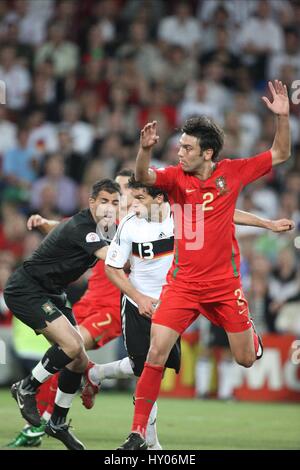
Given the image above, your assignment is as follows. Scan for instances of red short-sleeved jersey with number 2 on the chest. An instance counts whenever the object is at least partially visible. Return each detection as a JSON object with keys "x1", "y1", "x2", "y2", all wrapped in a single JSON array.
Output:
[{"x1": 154, "y1": 151, "x2": 272, "y2": 282}]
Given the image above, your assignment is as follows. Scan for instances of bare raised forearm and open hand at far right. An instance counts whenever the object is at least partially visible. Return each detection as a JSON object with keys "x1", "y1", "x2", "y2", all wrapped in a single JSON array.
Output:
[{"x1": 262, "y1": 80, "x2": 291, "y2": 165}]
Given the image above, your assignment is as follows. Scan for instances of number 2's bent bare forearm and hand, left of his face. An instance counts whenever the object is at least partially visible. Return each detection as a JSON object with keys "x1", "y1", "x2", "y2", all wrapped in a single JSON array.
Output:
[{"x1": 135, "y1": 121, "x2": 159, "y2": 185}]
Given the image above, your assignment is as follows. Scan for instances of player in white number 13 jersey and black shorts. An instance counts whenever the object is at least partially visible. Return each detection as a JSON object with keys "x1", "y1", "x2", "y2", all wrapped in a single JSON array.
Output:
[{"x1": 104, "y1": 178, "x2": 180, "y2": 450}]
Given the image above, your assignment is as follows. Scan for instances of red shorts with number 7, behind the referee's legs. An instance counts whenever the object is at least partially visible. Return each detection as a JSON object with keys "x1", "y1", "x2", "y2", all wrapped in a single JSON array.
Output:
[{"x1": 73, "y1": 299, "x2": 122, "y2": 348}]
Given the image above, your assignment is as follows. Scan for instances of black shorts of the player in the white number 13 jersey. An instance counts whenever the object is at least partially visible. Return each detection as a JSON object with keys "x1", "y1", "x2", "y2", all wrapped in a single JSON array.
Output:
[{"x1": 121, "y1": 296, "x2": 181, "y2": 377}]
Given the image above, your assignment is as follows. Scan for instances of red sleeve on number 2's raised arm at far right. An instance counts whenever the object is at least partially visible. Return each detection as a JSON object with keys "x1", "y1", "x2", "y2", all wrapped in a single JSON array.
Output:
[{"x1": 230, "y1": 150, "x2": 272, "y2": 186}]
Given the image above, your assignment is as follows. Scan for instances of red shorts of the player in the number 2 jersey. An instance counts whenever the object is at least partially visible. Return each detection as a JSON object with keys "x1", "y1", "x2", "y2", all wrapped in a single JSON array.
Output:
[{"x1": 152, "y1": 278, "x2": 251, "y2": 335}]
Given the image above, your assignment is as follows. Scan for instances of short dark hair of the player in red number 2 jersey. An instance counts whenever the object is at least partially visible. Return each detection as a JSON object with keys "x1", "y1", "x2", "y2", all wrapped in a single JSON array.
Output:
[{"x1": 181, "y1": 116, "x2": 224, "y2": 161}]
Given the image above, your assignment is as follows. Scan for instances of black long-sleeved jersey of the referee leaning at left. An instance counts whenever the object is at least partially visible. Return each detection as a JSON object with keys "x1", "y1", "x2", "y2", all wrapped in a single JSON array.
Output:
[{"x1": 23, "y1": 209, "x2": 107, "y2": 294}]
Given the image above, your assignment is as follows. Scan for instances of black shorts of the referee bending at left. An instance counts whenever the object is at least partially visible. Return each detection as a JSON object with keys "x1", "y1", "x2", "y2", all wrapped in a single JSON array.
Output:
[{"x1": 4, "y1": 267, "x2": 77, "y2": 331}]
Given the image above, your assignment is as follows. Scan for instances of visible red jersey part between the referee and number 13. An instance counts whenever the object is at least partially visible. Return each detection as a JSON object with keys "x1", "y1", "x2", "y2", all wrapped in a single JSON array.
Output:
[{"x1": 80, "y1": 260, "x2": 121, "y2": 308}]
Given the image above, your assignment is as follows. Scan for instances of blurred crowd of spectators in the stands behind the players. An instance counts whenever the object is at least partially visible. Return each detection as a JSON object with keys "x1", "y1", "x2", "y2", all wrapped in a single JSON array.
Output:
[{"x1": 0, "y1": 0, "x2": 300, "y2": 335}]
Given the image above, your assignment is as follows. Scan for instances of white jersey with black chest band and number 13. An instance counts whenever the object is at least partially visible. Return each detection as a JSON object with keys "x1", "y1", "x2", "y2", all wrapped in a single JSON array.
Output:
[{"x1": 105, "y1": 207, "x2": 174, "y2": 305}]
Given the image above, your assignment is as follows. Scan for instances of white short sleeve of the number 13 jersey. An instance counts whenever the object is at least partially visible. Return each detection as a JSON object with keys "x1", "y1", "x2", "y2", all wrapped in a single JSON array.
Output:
[{"x1": 105, "y1": 221, "x2": 132, "y2": 268}]
